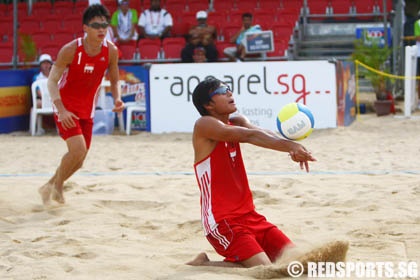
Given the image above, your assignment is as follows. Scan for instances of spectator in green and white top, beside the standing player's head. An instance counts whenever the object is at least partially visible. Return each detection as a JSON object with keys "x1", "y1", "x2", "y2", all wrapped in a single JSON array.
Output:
[{"x1": 111, "y1": 0, "x2": 138, "y2": 45}]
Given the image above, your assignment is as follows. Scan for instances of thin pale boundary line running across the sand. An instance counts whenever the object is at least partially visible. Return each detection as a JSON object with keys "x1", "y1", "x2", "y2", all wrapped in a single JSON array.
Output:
[{"x1": 0, "y1": 170, "x2": 420, "y2": 178}]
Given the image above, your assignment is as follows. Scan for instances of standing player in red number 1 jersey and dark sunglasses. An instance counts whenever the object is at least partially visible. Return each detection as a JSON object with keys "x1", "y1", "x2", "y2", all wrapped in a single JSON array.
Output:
[{"x1": 39, "y1": 4, "x2": 124, "y2": 204}]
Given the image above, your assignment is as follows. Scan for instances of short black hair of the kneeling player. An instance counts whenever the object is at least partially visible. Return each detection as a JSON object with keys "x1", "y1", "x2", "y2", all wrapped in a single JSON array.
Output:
[{"x1": 193, "y1": 78, "x2": 222, "y2": 116}]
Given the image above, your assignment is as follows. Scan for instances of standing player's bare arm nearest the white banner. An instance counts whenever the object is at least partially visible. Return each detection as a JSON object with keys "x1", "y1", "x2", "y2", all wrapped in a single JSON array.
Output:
[{"x1": 108, "y1": 43, "x2": 124, "y2": 112}]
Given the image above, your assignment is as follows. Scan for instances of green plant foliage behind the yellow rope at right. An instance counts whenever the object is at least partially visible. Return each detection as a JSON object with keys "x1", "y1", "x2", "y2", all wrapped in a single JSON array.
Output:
[{"x1": 351, "y1": 36, "x2": 392, "y2": 99}]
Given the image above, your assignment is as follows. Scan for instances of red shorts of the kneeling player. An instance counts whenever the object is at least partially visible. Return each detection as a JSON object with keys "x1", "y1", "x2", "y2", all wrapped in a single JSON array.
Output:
[{"x1": 207, "y1": 211, "x2": 292, "y2": 262}]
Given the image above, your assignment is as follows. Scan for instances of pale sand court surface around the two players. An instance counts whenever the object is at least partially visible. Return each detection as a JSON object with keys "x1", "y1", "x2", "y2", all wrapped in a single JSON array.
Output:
[{"x1": 0, "y1": 114, "x2": 420, "y2": 280}]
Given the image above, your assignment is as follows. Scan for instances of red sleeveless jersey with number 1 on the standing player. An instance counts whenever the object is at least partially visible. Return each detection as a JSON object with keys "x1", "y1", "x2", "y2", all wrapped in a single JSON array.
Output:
[{"x1": 58, "y1": 38, "x2": 109, "y2": 119}]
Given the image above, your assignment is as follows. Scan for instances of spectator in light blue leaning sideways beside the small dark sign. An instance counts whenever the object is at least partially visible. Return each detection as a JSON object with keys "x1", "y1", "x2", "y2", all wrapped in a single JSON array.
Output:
[{"x1": 223, "y1": 13, "x2": 261, "y2": 61}]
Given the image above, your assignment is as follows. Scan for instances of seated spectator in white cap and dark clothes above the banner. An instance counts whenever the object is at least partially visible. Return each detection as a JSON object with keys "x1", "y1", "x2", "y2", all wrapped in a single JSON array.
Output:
[{"x1": 181, "y1": 11, "x2": 218, "y2": 62}]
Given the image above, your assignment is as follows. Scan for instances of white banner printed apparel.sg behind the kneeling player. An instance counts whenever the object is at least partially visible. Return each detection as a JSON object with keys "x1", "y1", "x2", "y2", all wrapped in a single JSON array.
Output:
[{"x1": 150, "y1": 61, "x2": 337, "y2": 133}]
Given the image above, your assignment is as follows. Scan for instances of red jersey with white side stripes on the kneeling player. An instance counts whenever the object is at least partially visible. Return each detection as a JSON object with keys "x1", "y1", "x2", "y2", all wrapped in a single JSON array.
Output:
[{"x1": 194, "y1": 142, "x2": 255, "y2": 235}]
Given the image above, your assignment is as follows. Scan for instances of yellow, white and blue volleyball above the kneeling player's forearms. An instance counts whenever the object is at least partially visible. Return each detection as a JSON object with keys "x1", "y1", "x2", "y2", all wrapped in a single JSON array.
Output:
[{"x1": 277, "y1": 102, "x2": 315, "y2": 140}]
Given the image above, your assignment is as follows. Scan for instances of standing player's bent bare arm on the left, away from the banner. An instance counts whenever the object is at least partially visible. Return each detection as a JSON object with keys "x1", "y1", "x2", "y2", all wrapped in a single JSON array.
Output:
[{"x1": 48, "y1": 40, "x2": 78, "y2": 129}]
